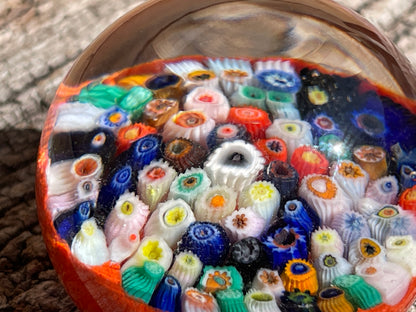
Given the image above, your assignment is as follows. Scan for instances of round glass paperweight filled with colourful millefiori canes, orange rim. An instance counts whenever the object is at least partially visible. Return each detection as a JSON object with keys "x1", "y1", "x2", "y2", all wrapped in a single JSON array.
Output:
[{"x1": 36, "y1": 0, "x2": 416, "y2": 312}]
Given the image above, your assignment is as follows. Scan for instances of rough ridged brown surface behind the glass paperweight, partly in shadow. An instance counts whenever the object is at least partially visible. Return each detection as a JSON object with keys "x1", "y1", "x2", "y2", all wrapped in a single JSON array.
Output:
[{"x1": 0, "y1": 0, "x2": 416, "y2": 311}]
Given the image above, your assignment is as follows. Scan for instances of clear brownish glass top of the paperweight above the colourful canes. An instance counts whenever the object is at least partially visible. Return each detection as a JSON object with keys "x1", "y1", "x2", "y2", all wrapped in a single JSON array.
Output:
[{"x1": 65, "y1": 0, "x2": 416, "y2": 98}]
